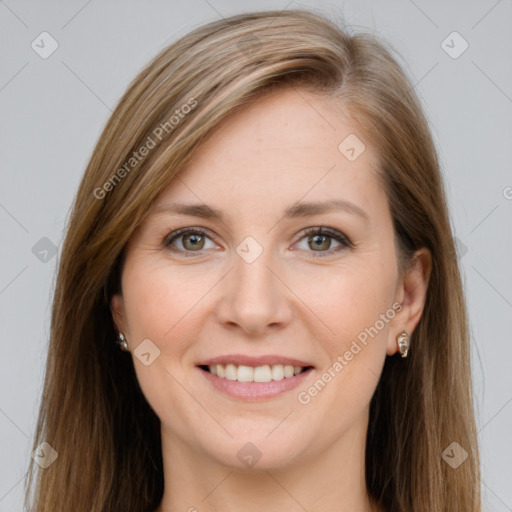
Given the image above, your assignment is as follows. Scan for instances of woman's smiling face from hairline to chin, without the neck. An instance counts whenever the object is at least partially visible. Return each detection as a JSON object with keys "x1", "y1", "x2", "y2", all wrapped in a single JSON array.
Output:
[{"x1": 112, "y1": 89, "x2": 410, "y2": 468}]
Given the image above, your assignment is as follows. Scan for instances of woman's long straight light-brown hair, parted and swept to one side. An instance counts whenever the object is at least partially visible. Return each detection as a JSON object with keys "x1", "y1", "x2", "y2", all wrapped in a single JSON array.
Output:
[{"x1": 26, "y1": 10, "x2": 481, "y2": 512}]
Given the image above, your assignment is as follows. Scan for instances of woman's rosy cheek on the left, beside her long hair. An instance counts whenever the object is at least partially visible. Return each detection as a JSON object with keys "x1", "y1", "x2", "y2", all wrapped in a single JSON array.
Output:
[{"x1": 119, "y1": 258, "x2": 213, "y2": 437}]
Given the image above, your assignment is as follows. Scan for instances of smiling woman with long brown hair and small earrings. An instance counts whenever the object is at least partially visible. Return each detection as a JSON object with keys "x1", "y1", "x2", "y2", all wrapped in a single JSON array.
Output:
[{"x1": 23, "y1": 10, "x2": 480, "y2": 512}]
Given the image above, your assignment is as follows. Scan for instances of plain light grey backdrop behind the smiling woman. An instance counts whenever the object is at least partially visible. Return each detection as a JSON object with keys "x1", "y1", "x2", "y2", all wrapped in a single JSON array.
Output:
[{"x1": 0, "y1": 0, "x2": 512, "y2": 512}]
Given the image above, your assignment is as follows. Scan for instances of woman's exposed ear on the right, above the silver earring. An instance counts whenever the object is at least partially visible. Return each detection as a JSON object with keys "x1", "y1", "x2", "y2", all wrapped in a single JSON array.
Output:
[{"x1": 386, "y1": 247, "x2": 432, "y2": 356}]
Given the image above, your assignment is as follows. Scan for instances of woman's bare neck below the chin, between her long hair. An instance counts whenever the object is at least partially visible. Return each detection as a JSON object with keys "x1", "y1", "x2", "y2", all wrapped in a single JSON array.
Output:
[{"x1": 155, "y1": 410, "x2": 380, "y2": 512}]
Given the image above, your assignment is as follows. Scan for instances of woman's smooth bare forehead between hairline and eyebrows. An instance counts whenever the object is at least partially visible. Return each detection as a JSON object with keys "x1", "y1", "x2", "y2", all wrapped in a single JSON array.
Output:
[{"x1": 148, "y1": 88, "x2": 385, "y2": 222}]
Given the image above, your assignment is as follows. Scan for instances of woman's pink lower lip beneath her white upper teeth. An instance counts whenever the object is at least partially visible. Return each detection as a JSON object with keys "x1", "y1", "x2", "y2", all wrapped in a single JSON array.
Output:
[{"x1": 198, "y1": 368, "x2": 313, "y2": 401}]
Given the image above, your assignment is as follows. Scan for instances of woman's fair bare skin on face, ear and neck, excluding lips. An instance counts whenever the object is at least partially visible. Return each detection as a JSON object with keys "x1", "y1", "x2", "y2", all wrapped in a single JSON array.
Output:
[{"x1": 111, "y1": 89, "x2": 431, "y2": 512}]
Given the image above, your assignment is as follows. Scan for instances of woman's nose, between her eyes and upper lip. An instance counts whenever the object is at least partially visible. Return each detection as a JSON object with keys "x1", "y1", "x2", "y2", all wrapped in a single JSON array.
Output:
[{"x1": 216, "y1": 243, "x2": 292, "y2": 336}]
